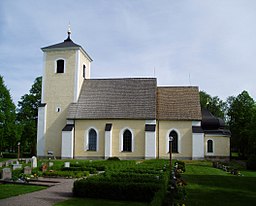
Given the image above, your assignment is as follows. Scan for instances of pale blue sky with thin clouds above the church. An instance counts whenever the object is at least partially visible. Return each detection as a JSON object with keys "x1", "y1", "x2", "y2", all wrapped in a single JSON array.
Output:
[{"x1": 0, "y1": 0, "x2": 256, "y2": 105}]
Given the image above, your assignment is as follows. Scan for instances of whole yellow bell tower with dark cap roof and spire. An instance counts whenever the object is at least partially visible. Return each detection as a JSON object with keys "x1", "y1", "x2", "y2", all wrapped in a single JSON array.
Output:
[{"x1": 37, "y1": 26, "x2": 92, "y2": 157}]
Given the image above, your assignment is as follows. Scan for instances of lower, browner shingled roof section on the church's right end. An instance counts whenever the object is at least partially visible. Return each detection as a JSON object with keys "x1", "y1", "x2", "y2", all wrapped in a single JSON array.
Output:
[{"x1": 157, "y1": 87, "x2": 202, "y2": 120}]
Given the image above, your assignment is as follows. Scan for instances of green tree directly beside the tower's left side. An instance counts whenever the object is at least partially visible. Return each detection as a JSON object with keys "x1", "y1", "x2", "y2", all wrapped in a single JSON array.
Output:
[{"x1": 17, "y1": 77, "x2": 42, "y2": 155}]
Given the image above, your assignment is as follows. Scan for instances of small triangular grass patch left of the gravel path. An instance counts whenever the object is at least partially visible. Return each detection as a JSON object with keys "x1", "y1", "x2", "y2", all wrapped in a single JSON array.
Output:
[{"x1": 0, "y1": 184, "x2": 47, "y2": 199}]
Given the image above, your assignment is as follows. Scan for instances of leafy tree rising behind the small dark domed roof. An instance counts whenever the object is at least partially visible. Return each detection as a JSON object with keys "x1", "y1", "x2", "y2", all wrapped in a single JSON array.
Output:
[{"x1": 199, "y1": 91, "x2": 226, "y2": 119}]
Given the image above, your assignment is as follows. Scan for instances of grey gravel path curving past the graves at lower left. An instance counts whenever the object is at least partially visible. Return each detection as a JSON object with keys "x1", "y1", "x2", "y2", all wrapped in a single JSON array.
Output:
[{"x1": 0, "y1": 179, "x2": 75, "y2": 206}]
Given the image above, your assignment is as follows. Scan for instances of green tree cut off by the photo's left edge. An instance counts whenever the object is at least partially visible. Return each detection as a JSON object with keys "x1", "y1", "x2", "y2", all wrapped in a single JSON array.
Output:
[{"x1": 0, "y1": 76, "x2": 17, "y2": 152}]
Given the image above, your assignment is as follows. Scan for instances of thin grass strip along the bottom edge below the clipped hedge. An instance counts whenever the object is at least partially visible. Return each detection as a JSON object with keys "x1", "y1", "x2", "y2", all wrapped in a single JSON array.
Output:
[{"x1": 54, "y1": 198, "x2": 147, "y2": 206}]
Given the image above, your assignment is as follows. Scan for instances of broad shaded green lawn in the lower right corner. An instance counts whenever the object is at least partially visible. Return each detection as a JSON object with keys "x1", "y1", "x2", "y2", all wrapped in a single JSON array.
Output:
[{"x1": 182, "y1": 161, "x2": 256, "y2": 206}]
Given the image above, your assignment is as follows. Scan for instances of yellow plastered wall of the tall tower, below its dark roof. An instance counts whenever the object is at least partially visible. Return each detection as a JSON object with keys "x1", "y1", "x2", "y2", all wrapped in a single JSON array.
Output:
[{"x1": 42, "y1": 49, "x2": 90, "y2": 156}]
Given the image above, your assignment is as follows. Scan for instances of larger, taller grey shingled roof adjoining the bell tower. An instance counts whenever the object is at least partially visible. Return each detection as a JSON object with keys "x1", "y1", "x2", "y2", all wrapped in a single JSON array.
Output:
[{"x1": 67, "y1": 78, "x2": 157, "y2": 119}]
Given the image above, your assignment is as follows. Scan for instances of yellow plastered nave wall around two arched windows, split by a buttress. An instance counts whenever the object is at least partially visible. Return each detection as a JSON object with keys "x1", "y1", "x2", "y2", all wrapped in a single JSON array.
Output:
[{"x1": 74, "y1": 120, "x2": 145, "y2": 159}]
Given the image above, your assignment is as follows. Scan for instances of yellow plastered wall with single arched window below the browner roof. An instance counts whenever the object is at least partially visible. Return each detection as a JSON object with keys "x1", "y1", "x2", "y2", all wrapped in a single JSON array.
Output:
[{"x1": 158, "y1": 120, "x2": 192, "y2": 159}]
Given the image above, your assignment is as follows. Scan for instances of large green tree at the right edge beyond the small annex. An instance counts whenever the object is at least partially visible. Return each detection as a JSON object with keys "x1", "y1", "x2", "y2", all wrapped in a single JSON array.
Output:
[{"x1": 227, "y1": 91, "x2": 256, "y2": 157}]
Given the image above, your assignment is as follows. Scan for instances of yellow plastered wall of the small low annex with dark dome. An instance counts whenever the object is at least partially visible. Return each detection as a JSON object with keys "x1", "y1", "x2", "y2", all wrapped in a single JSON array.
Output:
[{"x1": 204, "y1": 135, "x2": 230, "y2": 157}]
